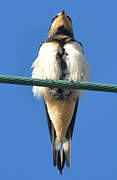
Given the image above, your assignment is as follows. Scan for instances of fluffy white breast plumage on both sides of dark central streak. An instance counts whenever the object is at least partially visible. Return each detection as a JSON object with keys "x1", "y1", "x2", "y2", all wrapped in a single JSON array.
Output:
[{"x1": 32, "y1": 41, "x2": 89, "y2": 97}]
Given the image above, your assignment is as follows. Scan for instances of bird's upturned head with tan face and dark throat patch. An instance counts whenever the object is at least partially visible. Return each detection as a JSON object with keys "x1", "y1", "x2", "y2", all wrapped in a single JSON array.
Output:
[{"x1": 48, "y1": 10, "x2": 73, "y2": 38}]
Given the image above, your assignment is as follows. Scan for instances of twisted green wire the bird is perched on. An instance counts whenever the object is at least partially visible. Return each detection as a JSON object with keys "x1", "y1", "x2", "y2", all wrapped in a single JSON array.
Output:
[{"x1": 0, "y1": 75, "x2": 117, "y2": 93}]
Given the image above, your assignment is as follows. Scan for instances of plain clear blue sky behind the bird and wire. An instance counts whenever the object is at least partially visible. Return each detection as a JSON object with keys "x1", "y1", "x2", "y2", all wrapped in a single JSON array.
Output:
[{"x1": 0, "y1": 0, "x2": 117, "y2": 180}]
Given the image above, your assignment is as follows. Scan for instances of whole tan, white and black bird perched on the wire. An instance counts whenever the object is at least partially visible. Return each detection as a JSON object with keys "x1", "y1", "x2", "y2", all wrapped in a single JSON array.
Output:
[{"x1": 32, "y1": 10, "x2": 90, "y2": 174}]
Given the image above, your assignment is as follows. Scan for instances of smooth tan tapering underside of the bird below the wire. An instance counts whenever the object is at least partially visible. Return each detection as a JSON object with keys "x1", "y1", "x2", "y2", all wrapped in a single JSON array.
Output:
[{"x1": 46, "y1": 98, "x2": 76, "y2": 142}]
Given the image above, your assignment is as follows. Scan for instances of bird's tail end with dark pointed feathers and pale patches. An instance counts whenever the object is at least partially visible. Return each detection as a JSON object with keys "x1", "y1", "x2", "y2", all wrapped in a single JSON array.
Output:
[{"x1": 52, "y1": 139, "x2": 71, "y2": 174}]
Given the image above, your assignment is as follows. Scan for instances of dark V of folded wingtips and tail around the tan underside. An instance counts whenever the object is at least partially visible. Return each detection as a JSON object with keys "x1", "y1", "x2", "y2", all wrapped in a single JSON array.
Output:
[{"x1": 44, "y1": 99, "x2": 79, "y2": 174}]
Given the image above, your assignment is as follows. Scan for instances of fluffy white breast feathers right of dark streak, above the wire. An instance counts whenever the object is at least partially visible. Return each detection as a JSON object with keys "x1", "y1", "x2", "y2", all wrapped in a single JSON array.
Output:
[{"x1": 64, "y1": 41, "x2": 90, "y2": 81}]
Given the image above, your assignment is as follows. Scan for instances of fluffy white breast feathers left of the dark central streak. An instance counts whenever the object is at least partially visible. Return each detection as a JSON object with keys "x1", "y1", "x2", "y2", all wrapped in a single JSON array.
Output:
[{"x1": 32, "y1": 42, "x2": 62, "y2": 97}]
